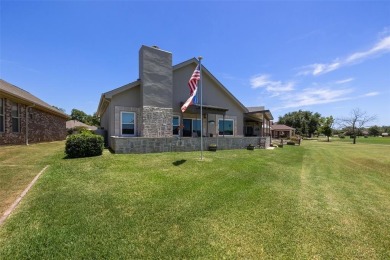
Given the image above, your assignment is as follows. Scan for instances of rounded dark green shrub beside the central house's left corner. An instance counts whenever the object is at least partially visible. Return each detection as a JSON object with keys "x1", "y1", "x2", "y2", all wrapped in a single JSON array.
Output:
[{"x1": 65, "y1": 132, "x2": 104, "y2": 158}]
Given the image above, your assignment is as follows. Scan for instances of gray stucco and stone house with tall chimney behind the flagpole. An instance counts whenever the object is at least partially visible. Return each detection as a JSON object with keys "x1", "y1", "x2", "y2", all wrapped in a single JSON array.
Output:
[{"x1": 97, "y1": 46, "x2": 273, "y2": 153}]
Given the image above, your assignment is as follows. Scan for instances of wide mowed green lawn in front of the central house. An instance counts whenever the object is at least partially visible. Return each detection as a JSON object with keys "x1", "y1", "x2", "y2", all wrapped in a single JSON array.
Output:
[{"x1": 0, "y1": 141, "x2": 390, "y2": 259}]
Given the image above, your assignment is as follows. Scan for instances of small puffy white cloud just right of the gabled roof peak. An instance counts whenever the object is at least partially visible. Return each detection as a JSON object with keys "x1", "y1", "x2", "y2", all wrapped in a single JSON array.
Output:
[{"x1": 250, "y1": 74, "x2": 295, "y2": 96}]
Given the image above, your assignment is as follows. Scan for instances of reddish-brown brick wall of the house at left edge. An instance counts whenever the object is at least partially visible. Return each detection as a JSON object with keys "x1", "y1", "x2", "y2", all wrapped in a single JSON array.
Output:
[{"x1": 0, "y1": 99, "x2": 66, "y2": 145}]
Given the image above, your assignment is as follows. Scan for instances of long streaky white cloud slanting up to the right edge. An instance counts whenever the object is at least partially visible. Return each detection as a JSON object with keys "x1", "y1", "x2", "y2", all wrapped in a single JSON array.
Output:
[{"x1": 298, "y1": 36, "x2": 390, "y2": 76}]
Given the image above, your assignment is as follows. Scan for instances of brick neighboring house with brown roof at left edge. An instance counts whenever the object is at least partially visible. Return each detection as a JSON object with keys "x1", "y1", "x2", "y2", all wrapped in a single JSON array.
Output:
[{"x1": 0, "y1": 79, "x2": 69, "y2": 145}]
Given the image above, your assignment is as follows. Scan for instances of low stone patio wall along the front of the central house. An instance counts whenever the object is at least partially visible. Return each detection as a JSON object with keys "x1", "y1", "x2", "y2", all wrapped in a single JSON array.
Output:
[{"x1": 110, "y1": 136, "x2": 271, "y2": 154}]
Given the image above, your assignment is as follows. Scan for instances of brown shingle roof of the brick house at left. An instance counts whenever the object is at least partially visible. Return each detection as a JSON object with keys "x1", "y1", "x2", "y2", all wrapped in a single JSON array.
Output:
[{"x1": 0, "y1": 79, "x2": 69, "y2": 118}]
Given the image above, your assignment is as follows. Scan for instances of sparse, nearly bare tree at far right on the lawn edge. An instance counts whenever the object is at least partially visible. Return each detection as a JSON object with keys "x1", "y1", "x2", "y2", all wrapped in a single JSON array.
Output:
[{"x1": 338, "y1": 108, "x2": 376, "y2": 144}]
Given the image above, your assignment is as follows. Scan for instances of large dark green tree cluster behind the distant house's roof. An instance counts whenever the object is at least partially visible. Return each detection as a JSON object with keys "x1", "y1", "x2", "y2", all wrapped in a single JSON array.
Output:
[{"x1": 278, "y1": 110, "x2": 321, "y2": 136}]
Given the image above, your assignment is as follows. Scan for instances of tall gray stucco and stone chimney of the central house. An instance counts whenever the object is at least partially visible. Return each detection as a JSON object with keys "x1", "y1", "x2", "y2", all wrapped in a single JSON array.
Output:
[{"x1": 139, "y1": 45, "x2": 173, "y2": 137}]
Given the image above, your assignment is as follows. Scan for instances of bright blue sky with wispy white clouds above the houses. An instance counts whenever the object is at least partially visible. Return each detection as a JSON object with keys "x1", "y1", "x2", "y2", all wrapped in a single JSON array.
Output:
[{"x1": 0, "y1": 0, "x2": 390, "y2": 125}]
